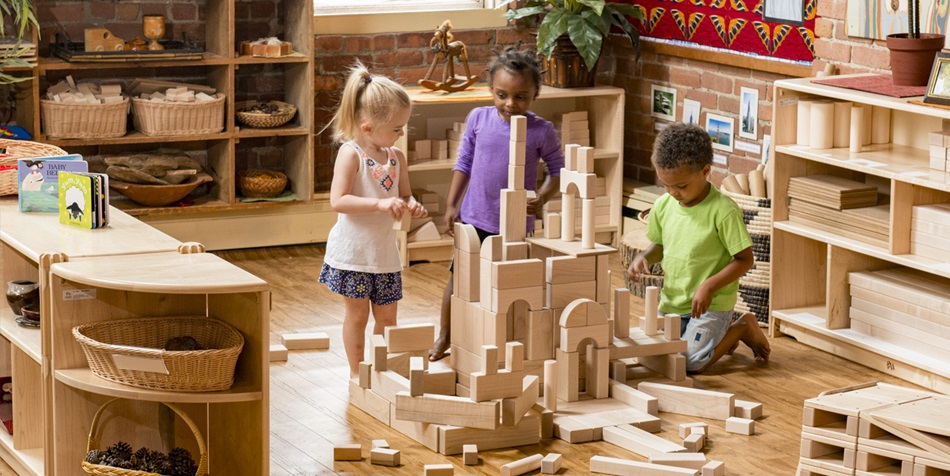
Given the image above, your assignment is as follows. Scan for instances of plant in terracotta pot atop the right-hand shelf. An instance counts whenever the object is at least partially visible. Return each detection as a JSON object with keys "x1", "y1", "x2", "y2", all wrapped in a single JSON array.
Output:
[{"x1": 887, "y1": 0, "x2": 946, "y2": 86}]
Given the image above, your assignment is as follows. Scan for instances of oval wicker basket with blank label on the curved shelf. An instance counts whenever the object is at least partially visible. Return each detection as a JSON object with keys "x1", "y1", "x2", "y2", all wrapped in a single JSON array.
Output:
[{"x1": 73, "y1": 316, "x2": 244, "y2": 392}]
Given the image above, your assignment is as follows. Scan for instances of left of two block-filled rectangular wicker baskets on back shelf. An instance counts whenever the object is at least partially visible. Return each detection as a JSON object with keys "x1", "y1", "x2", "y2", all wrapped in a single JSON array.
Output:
[{"x1": 40, "y1": 98, "x2": 129, "y2": 139}]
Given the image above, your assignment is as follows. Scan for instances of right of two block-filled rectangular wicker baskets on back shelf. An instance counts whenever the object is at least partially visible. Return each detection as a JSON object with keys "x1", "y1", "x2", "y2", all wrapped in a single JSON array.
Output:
[{"x1": 132, "y1": 93, "x2": 225, "y2": 136}]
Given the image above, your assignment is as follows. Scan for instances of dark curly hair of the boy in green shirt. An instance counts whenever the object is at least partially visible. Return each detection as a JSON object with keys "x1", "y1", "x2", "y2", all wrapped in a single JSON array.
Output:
[{"x1": 650, "y1": 122, "x2": 712, "y2": 172}]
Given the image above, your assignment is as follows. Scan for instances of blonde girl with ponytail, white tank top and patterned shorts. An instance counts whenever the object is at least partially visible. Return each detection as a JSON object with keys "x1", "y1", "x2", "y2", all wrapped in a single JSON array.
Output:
[{"x1": 320, "y1": 63, "x2": 427, "y2": 377}]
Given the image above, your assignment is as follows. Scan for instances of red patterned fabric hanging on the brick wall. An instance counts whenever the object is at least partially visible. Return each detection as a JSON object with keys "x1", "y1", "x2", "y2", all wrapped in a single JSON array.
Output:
[{"x1": 618, "y1": 0, "x2": 817, "y2": 62}]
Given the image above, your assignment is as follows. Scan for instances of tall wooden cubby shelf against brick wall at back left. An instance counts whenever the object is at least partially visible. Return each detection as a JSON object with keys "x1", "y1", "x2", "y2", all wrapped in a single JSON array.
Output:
[{"x1": 11, "y1": 0, "x2": 336, "y2": 250}]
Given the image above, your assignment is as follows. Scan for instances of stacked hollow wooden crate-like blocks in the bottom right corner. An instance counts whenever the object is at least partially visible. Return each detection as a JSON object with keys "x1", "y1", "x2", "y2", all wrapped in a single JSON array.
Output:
[{"x1": 798, "y1": 383, "x2": 950, "y2": 476}]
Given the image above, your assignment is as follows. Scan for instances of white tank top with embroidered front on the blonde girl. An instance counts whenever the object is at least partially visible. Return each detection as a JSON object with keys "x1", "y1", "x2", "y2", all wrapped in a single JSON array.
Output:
[{"x1": 323, "y1": 141, "x2": 402, "y2": 273}]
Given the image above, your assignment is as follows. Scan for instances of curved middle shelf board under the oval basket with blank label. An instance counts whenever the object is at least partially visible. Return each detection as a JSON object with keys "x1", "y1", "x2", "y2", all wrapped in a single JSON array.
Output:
[{"x1": 55, "y1": 368, "x2": 262, "y2": 403}]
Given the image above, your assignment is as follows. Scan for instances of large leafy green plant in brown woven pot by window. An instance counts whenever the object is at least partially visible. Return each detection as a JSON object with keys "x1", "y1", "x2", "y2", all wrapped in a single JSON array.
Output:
[{"x1": 505, "y1": 0, "x2": 643, "y2": 87}]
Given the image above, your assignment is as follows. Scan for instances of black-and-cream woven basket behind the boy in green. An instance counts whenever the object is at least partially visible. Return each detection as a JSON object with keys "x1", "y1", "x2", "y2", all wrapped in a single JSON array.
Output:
[{"x1": 722, "y1": 190, "x2": 772, "y2": 325}]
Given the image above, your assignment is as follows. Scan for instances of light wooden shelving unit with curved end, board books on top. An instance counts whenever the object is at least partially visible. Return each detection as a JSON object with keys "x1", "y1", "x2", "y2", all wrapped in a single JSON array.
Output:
[{"x1": 0, "y1": 197, "x2": 270, "y2": 475}]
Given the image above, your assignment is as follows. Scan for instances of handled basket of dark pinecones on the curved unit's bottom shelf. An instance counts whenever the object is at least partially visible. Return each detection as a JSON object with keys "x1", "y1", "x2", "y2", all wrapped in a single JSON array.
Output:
[{"x1": 82, "y1": 398, "x2": 208, "y2": 476}]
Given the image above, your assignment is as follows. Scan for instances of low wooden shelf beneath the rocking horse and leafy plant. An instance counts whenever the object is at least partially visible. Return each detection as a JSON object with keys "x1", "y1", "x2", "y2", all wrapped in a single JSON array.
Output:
[{"x1": 396, "y1": 85, "x2": 625, "y2": 265}]
